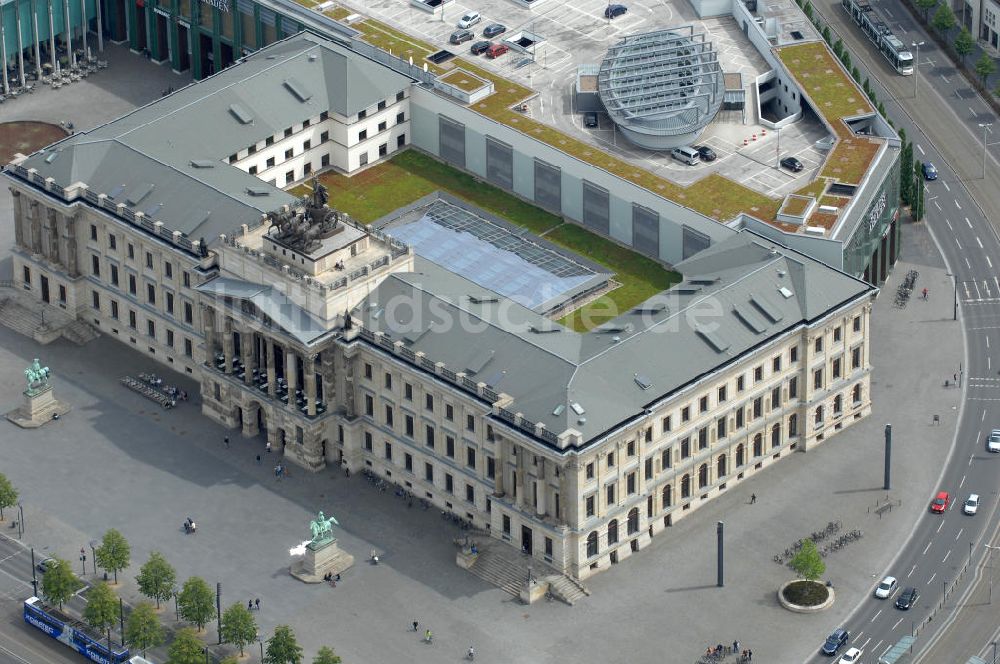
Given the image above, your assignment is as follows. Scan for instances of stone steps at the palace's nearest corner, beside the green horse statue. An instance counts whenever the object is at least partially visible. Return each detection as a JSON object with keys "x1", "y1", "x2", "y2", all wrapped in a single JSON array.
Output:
[{"x1": 469, "y1": 536, "x2": 590, "y2": 606}]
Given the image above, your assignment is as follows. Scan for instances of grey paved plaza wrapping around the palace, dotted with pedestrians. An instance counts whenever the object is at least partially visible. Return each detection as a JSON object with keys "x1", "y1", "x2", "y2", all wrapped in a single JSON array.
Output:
[{"x1": 0, "y1": 48, "x2": 963, "y2": 664}]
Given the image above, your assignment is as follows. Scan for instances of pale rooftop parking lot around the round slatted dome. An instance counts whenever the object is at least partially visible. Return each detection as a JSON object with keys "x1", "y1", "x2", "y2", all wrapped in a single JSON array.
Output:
[{"x1": 347, "y1": 0, "x2": 826, "y2": 196}]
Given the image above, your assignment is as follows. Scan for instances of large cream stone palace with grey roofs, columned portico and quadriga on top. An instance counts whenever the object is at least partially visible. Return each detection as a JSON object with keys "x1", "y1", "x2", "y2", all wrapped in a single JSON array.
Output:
[{"x1": 4, "y1": 33, "x2": 877, "y2": 578}]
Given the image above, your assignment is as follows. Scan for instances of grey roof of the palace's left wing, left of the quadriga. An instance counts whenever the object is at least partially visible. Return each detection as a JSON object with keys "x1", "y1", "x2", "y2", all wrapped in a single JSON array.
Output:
[{"x1": 11, "y1": 33, "x2": 411, "y2": 244}]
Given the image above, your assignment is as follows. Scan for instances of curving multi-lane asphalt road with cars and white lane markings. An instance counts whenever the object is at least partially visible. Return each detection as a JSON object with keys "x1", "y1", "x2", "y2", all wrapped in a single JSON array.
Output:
[{"x1": 816, "y1": 0, "x2": 1000, "y2": 662}]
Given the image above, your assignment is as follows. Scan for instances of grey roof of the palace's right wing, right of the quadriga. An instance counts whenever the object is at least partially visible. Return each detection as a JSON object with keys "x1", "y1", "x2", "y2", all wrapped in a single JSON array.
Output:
[{"x1": 354, "y1": 231, "x2": 876, "y2": 442}]
